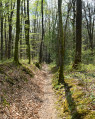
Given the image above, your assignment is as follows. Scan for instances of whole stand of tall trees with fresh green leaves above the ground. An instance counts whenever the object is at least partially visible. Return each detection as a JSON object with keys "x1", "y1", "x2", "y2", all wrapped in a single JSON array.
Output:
[{"x1": 0, "y1": 0, "x2": 95, "y2": 72}]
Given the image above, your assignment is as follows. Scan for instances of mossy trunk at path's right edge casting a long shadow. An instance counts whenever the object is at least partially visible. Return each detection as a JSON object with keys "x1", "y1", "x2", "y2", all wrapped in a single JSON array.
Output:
[{"x1": 58, "y1": 0, "x2": 64, "y2": 83}]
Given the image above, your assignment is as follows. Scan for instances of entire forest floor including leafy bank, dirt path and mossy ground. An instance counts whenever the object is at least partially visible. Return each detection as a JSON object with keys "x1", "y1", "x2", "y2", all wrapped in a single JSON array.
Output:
[{"x1": 0, "y1": 63, "x2": 95, "y2": 119}]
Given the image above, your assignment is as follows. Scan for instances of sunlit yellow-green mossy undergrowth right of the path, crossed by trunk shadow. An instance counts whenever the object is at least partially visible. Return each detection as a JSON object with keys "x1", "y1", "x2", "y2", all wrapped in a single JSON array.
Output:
[{"x1": 52, "y1": 64, "x2": 95, "y2": 119}]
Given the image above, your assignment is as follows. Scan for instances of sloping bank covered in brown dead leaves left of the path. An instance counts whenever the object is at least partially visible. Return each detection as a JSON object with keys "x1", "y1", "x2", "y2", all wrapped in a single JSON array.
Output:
[{"x1": 0, "y1": 63, "x2": 44, "y2": 119}]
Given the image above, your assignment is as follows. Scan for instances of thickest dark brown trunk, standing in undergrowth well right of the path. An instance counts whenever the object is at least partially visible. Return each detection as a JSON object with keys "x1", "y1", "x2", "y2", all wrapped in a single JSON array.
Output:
[{"x1": 73, "y1": 0, "x2": 82, "y2": 68}]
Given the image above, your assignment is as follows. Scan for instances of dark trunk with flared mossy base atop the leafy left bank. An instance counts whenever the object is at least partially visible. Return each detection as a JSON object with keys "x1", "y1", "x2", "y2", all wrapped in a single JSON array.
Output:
[{"x1": 14, "y1": 0, "x2": 20, "y2": 64}]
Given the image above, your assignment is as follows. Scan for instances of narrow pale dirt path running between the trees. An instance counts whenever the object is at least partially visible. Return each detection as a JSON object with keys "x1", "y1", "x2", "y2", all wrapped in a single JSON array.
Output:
[{"x1": 39, "y1": 65, "x2": 58, "y2": 119}]
